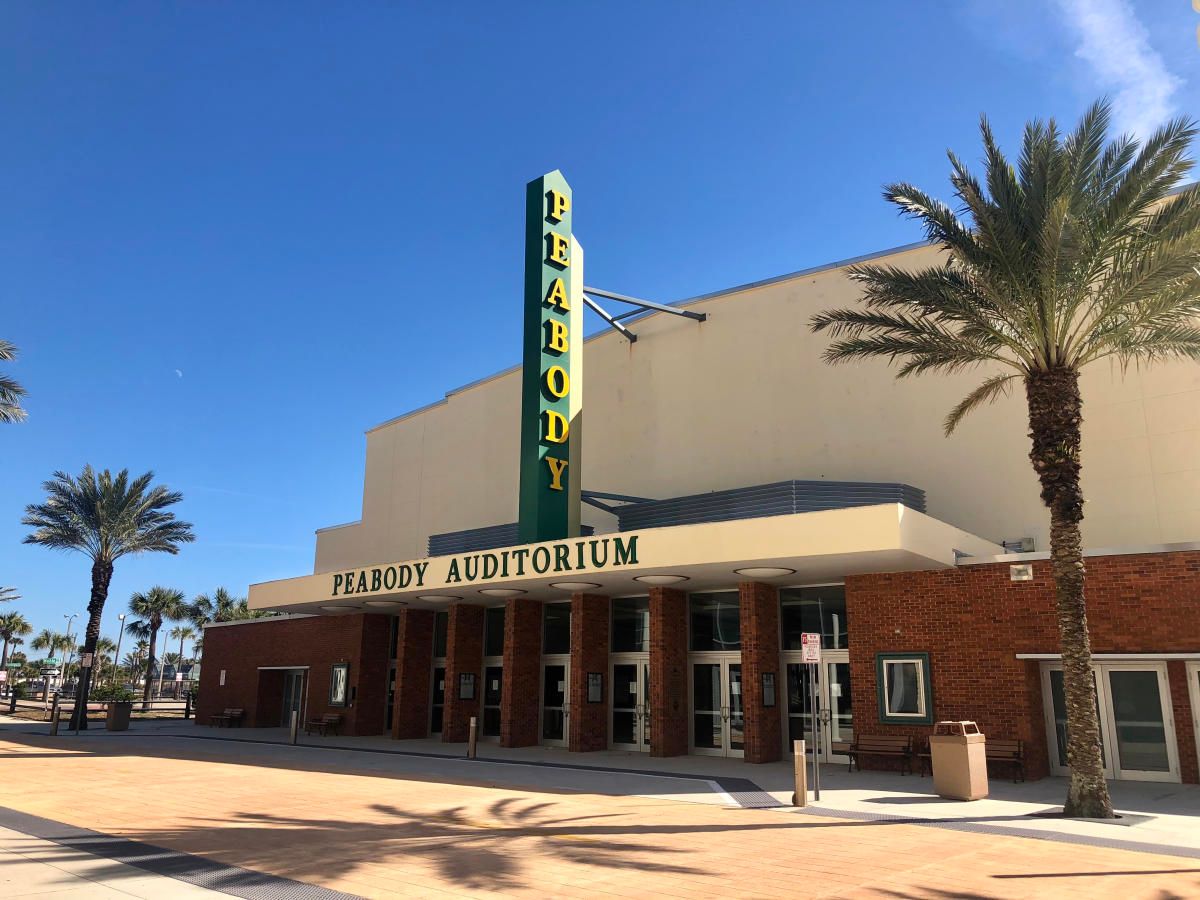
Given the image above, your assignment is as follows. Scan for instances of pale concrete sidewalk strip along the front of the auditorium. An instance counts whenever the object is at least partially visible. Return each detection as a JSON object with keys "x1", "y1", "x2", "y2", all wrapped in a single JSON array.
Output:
[{"x1": 11, "y1": 721, "x2": 1200, "y2": 858}]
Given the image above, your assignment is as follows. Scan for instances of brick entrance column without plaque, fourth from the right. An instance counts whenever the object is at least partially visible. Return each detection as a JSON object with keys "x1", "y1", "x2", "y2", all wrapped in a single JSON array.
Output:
[{"x1": 500, "y1": 596, "x2": 541, "y2": 746}]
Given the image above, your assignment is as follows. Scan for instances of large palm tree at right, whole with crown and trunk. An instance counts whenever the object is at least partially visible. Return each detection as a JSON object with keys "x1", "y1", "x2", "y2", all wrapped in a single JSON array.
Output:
[{"x1": 812, "y1": 101, "x2": 1200, "y2": 818}]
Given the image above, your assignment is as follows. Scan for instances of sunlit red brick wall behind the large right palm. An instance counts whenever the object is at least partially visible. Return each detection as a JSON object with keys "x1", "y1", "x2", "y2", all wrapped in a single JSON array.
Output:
[{"x1": 846, "y1": 552, "x2": 1200, "y2": 782}]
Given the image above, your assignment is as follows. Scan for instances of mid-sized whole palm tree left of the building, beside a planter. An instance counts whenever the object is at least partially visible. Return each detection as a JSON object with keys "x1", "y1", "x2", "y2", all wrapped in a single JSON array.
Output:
[{"x1": 22, "y1": 466, "x2": 196, "y2": 728}]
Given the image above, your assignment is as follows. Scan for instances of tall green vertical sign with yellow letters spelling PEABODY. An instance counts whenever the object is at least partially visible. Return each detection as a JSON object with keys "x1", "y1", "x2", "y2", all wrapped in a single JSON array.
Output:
[{"x1": 518, "y1": 169, "x2": 583, "y2": 544}]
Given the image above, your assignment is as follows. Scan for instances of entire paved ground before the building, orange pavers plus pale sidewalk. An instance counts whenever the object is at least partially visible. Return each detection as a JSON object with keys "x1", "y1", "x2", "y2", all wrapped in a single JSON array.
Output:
[{"x1": 0, "y1": 721, "x2": 1200, "y2": 898}]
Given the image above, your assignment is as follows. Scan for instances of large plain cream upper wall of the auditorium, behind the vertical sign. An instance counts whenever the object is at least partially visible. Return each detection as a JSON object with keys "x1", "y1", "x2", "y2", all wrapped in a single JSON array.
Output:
[{"x1": 314, "y1": 245, "x2": 1200, "y2": 572}]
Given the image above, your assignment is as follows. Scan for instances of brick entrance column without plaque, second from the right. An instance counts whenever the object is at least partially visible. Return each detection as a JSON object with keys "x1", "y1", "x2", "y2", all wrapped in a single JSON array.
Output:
[{"x1": 649, "y1": 588, "x2": 690, "y2": 756}]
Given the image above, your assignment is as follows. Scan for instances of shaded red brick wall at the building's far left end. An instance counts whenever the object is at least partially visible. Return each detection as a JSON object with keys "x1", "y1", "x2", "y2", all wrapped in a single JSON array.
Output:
[{"x1": 196, "y1": 614, "x2": 390, "y2": 734}]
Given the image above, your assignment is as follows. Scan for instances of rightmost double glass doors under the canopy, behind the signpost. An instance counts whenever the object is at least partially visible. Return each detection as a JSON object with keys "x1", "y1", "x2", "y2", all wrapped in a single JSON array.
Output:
[{"x1": 784, "y1": 650, "x2": 854, "y2": 762}]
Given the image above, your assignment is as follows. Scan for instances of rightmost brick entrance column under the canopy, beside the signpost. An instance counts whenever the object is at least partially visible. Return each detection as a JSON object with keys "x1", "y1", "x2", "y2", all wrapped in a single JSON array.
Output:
[{"x1": 738, "y1": 581, "x2": 786, "y2": 762}]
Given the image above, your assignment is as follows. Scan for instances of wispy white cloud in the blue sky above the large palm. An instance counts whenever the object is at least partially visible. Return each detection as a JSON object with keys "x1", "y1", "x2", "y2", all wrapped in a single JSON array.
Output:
[{"x1": 1058, "y1": 0, "x2": 1182, "y2": 138}]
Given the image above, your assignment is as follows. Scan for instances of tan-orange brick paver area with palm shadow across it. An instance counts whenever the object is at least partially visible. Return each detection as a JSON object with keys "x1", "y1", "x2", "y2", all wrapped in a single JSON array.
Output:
[{"x1": 0, "y1": 737, "x2": 1200, "y2": 899}]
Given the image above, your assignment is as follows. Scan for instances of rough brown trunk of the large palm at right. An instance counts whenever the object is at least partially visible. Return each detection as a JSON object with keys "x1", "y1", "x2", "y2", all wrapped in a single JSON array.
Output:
[{"x1": 1025, "y1": 368, "x2": 1114, "y2": 818}]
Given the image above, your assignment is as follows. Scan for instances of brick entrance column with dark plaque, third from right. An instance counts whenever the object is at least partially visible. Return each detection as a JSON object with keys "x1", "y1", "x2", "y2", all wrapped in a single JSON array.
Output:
[{"x1": 568, "y1": 594, "x2": 612, "y2": 751}]
